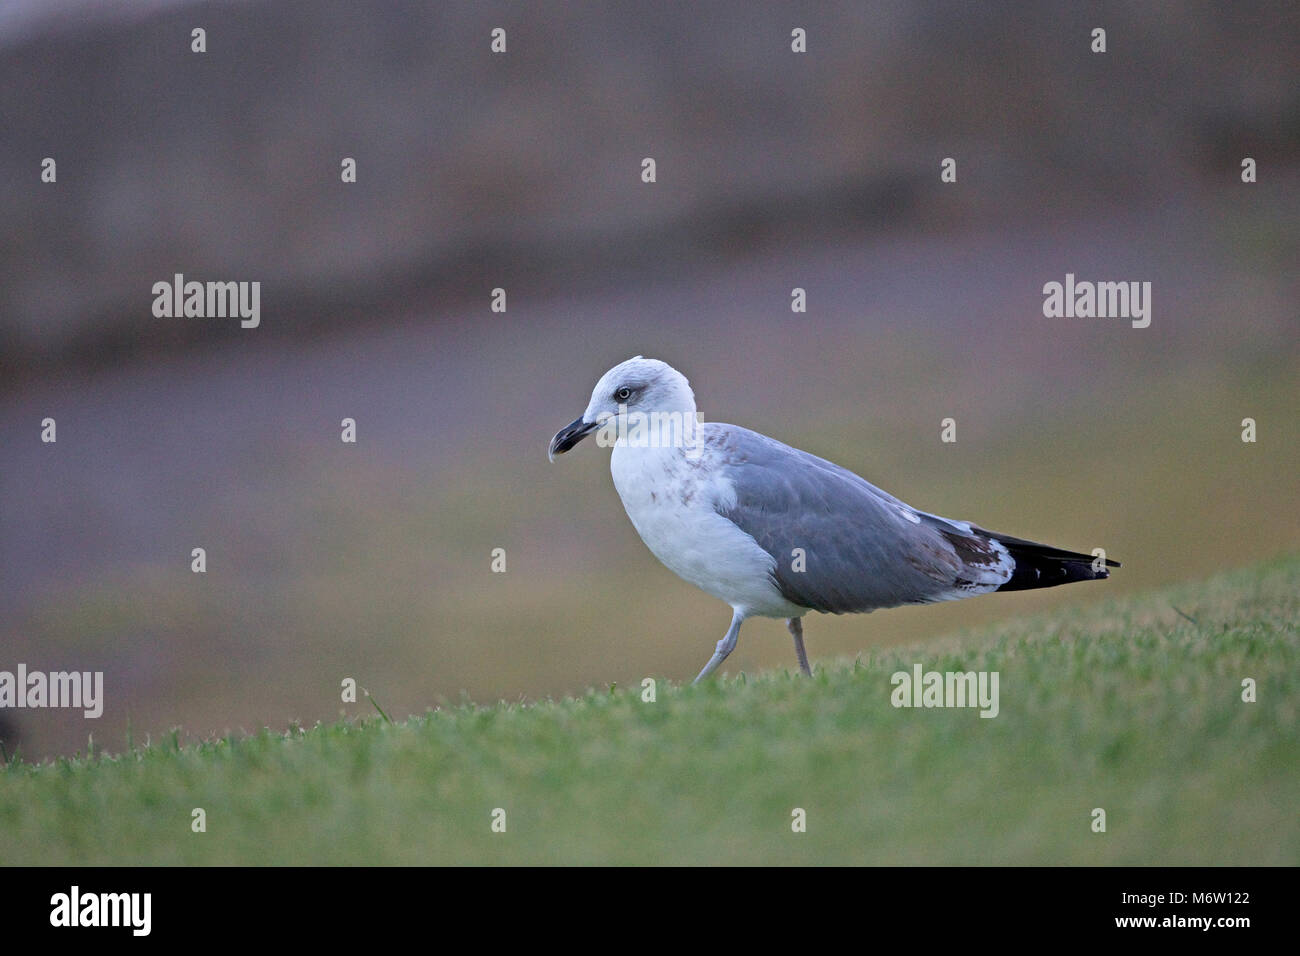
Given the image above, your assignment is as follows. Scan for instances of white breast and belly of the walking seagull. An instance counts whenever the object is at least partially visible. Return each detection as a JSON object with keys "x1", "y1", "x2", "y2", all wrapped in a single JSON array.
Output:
[{"x1": 610, "y1": 445, "x2": 806, "y2": 618}]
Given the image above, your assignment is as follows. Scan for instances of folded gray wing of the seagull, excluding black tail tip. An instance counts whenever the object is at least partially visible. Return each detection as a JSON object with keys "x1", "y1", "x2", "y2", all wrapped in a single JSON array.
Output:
[{"x1": 705, "y1": 424, "x2": 1014, "y2": 614}]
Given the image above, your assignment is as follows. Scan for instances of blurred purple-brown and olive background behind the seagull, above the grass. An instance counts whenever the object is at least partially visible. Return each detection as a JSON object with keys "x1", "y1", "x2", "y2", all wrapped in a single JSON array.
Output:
[{"x1": 0, "y1": 0, "x2": 1300, "y2": 758}]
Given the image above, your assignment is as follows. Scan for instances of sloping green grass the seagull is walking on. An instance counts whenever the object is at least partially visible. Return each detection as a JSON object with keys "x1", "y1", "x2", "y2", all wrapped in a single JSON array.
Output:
[{"x1": 0, "y1": 557, "x2": 1300, "y2": 865}]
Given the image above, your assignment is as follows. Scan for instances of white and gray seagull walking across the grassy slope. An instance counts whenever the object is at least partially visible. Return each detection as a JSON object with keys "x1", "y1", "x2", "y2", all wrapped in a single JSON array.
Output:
[{"x1": 547, "y1": 355, "x2": 1119, "y2": 683}]
